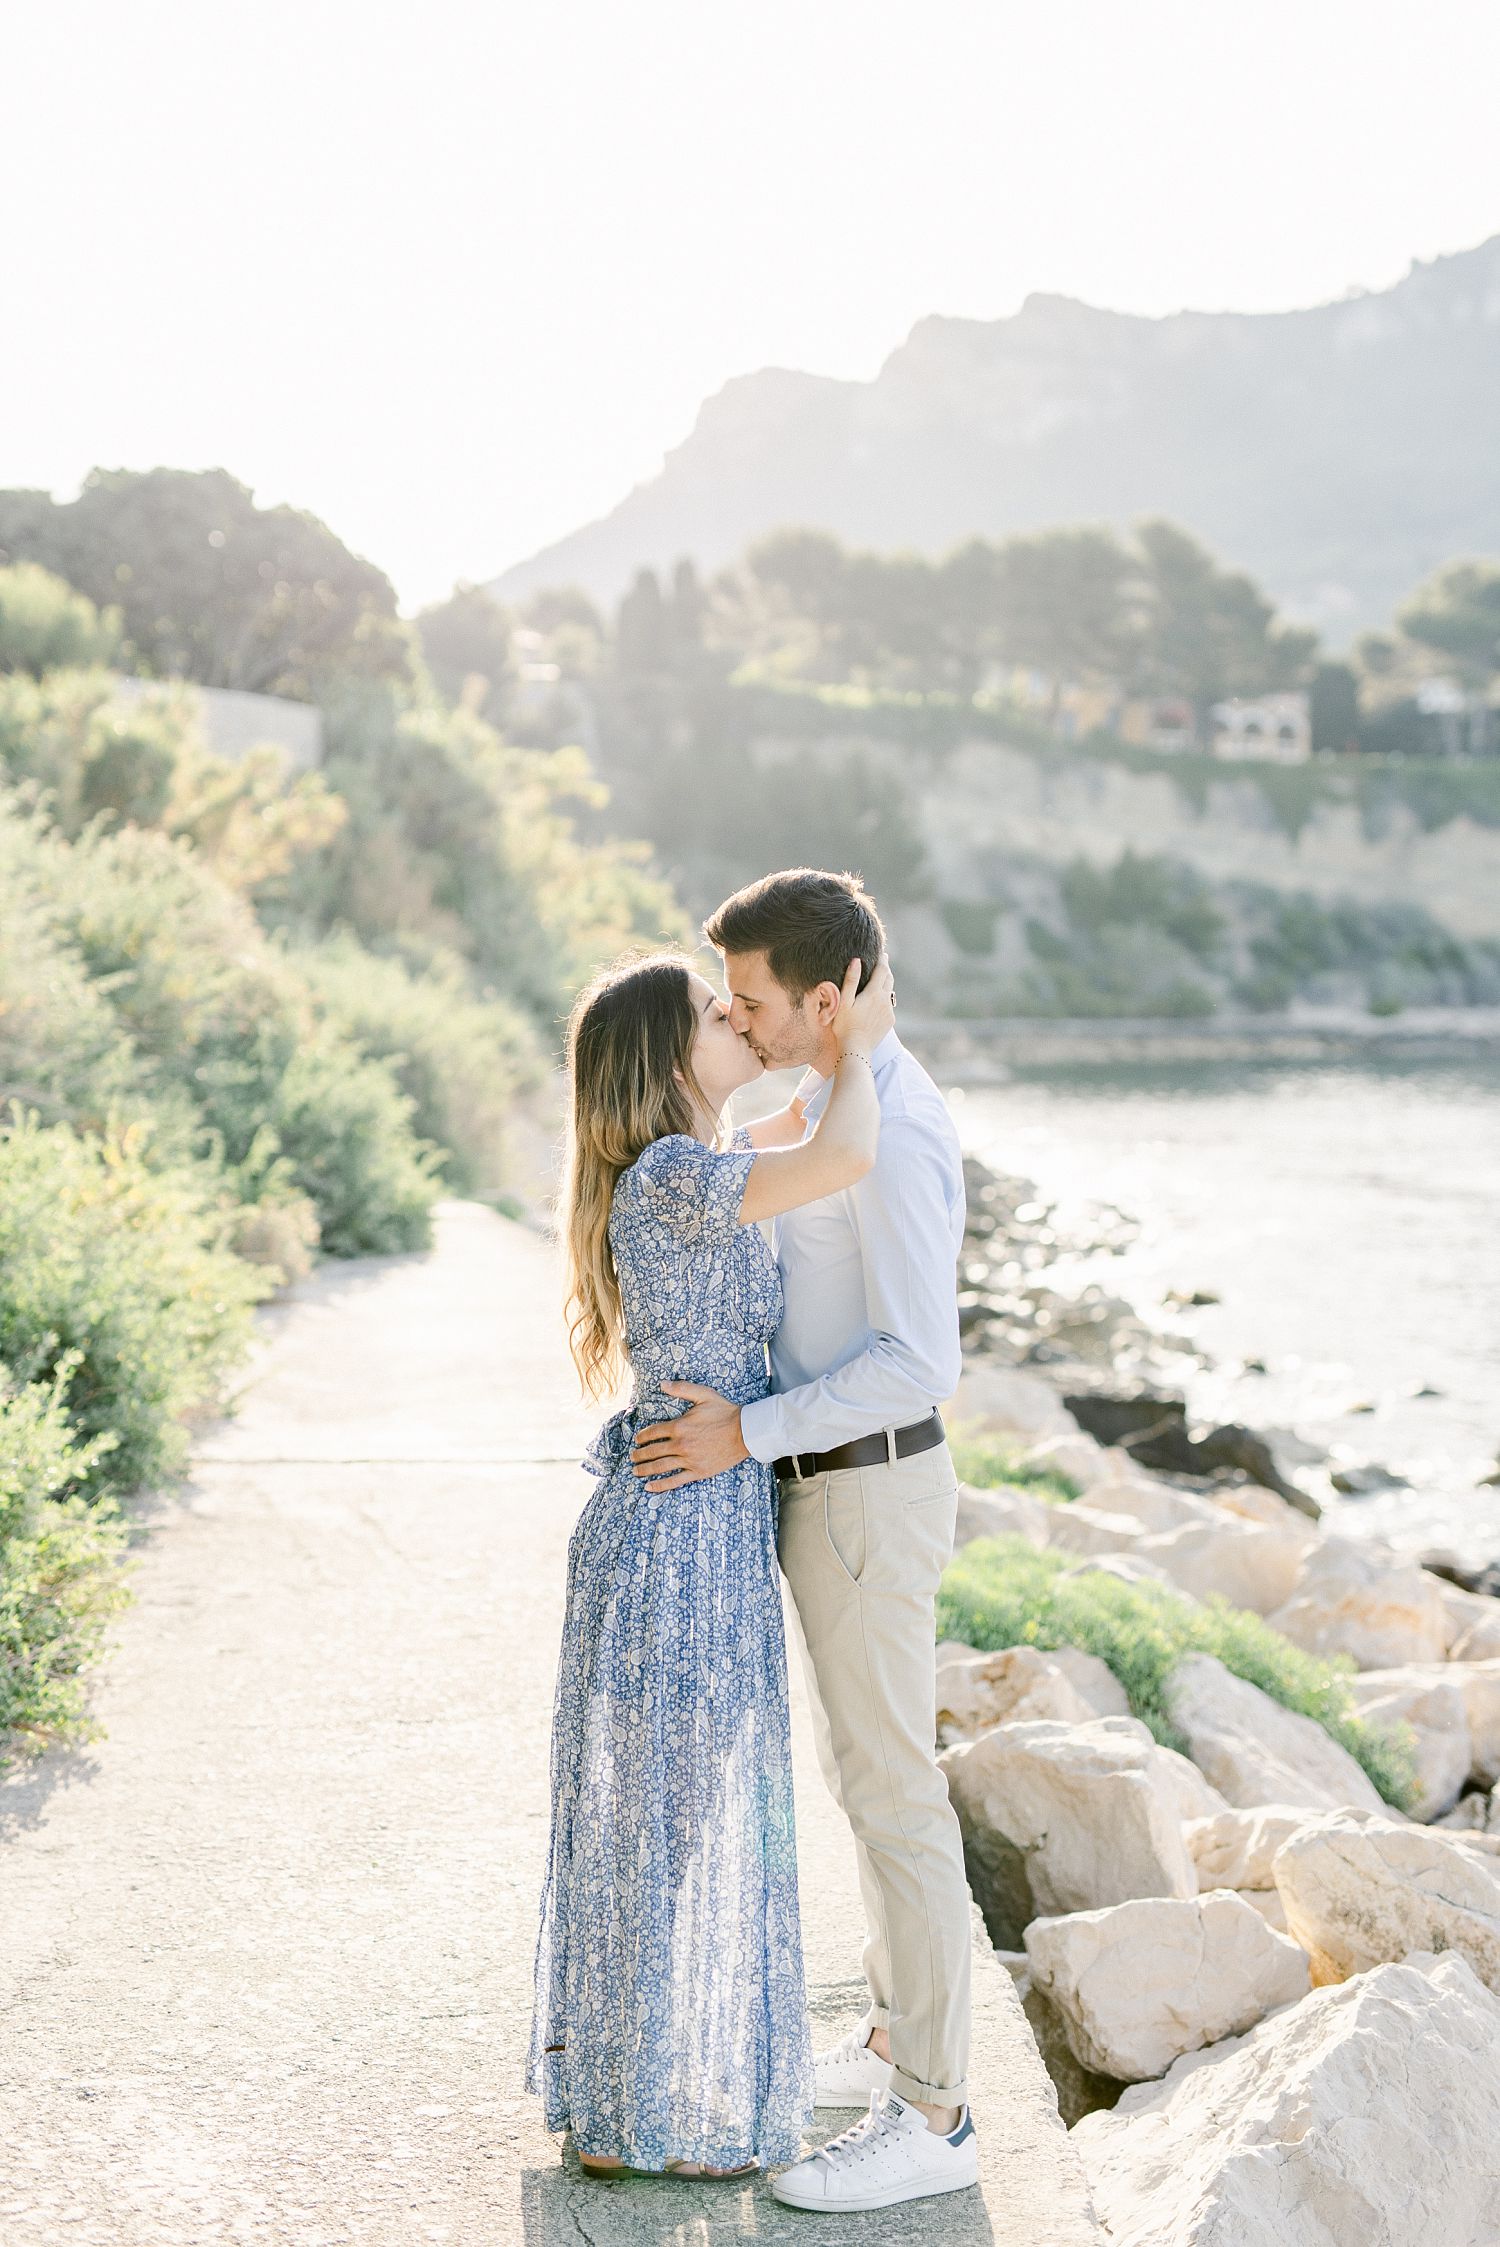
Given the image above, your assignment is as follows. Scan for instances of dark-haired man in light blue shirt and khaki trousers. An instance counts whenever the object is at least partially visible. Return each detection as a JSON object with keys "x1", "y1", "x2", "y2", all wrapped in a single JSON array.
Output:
[{"x1": 635, "y1": 870, "x2": 977, "y2": 2211}]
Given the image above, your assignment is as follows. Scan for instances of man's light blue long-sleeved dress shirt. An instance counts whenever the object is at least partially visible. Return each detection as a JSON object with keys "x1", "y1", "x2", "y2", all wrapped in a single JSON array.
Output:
[{"x1": 739, "y1": 1031, "x2": 963, "y2": 1461}]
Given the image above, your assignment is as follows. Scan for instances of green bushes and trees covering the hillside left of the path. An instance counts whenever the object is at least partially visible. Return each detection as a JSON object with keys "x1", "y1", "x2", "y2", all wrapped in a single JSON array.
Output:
[{"x1": 0, "y1": 492, "x2": 683, "y2": 1744}]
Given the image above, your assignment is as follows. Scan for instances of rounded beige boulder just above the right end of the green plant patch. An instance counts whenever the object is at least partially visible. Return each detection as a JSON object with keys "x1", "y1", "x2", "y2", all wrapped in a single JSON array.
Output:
[{"x1": 1269, "y1": 1537, "x2": 1453, "y2": 1670}]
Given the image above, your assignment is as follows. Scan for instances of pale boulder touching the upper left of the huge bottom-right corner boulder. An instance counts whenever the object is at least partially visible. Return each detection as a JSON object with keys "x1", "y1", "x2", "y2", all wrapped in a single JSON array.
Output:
[{"x1": 1026, "y1": 1887, "x2": 1309, "y2": 2083}]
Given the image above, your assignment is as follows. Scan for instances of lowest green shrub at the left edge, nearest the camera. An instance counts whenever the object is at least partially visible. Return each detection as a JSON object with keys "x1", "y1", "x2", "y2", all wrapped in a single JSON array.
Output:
[{"x1": 0, "y1": 1359, "x2": 126, "y2": 1746}]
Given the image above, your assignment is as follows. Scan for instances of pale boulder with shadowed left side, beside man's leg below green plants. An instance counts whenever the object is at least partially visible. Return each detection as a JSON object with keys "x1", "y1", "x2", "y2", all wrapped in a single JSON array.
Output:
[{"x1": 939, "y1": 1717, "x2": 1197, "y2": 1950}]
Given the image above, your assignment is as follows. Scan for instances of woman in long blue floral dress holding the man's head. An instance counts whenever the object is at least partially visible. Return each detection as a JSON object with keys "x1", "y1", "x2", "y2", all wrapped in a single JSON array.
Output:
[{"x1": 528, "y1": 959, "x2": 891, "y2": 2177}]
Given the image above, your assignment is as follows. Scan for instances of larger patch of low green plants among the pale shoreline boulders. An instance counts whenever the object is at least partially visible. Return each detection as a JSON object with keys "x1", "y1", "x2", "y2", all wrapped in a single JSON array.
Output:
[{"x1": 936, "y1": 1537, "x2": 1415, "y2": 1809}]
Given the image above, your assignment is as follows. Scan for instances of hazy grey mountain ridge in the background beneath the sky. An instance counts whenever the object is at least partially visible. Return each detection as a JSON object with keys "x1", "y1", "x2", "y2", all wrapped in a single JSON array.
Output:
[{"x1": 494, "y1": 234, "x2": 1500, "y2": 638}]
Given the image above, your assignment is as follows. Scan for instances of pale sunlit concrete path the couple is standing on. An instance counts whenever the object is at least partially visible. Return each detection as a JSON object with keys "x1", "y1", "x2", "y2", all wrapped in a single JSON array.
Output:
[{"x1": 0, "y1": 1202, "x2": 1098, "y2": 2247}]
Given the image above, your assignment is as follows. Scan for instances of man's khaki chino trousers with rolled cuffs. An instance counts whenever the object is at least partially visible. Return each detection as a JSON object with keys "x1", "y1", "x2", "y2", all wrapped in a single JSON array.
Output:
[{"x1": 779, "y1": 1443, "x2": 970, "y2": 2105}]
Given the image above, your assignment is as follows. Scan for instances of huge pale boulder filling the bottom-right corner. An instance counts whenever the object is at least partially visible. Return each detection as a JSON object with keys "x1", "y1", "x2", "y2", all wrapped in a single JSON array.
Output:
[{"x1": 1071, "y1": 1957, "x2": 1500, "y2": 2247}]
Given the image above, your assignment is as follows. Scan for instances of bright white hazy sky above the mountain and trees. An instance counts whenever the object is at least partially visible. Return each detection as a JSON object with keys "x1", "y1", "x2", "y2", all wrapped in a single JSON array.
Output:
[{"x1": 0, "y1": 0, "x2": 1500, "y2": 602}]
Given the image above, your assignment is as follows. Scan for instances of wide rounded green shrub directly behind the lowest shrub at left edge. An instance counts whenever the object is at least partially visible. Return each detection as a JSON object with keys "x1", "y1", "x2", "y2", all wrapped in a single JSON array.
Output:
[{"x1": 0, "y1": 1115, "x2": 267, "y2": 1497}]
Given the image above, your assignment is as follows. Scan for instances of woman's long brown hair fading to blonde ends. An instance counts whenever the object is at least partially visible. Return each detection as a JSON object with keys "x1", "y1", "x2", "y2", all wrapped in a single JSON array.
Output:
[{"x1": 559, "y1": 955, "x2": 701, "y2": 1398}]
